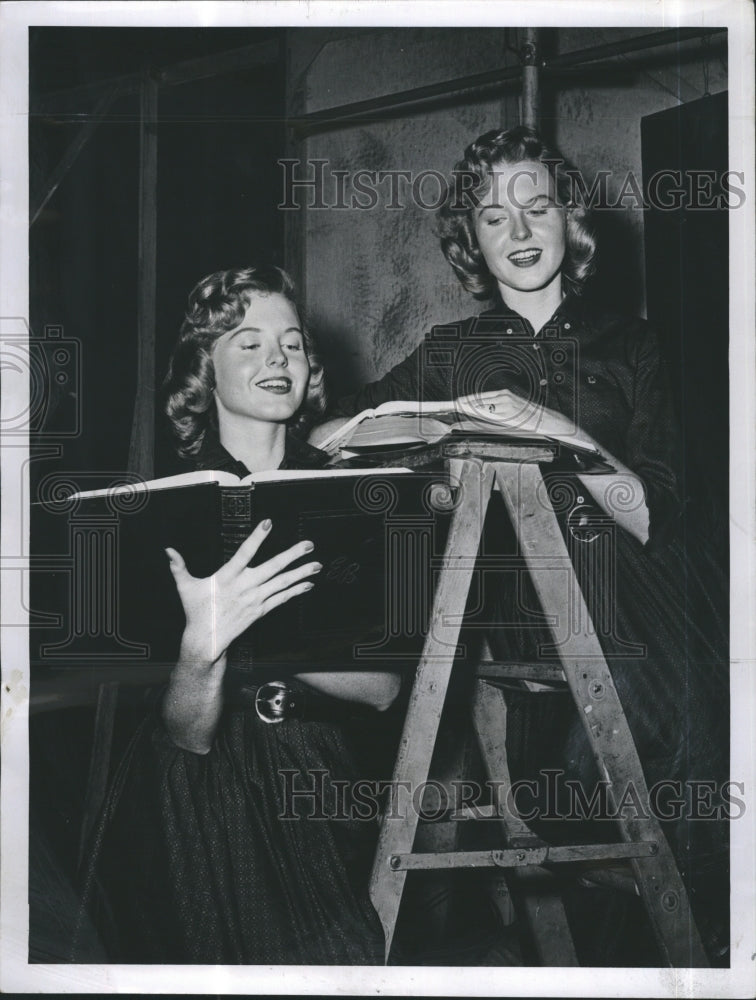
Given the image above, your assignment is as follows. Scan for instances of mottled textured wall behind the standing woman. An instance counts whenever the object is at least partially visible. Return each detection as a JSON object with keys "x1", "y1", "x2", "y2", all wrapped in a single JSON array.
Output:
[{"x1": 288, "y1": 29, "x2": 726, "y2": 392}]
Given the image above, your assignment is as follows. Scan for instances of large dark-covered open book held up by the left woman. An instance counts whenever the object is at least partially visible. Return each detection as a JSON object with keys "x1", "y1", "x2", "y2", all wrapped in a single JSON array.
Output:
[{"x1": 30, "y1": 468, "x2": 451, "y2": 677}]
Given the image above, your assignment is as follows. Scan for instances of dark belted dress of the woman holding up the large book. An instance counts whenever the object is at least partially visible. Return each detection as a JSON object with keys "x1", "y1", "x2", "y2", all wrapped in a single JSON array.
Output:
[{"x1": 74, "y1": 437, "x2": 384, "y2": 965}]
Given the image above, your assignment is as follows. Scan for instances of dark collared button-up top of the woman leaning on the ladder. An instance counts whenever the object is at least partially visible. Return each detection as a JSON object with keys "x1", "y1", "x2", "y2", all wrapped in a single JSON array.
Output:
[{"x1": 331, "y1": 295, "x2": 680, "y2": 538}]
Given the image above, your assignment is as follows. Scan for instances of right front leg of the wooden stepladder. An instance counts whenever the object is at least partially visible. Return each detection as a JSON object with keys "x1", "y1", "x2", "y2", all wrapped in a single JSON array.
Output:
[{"x1": 496, "y1": 463, "x2": 708, "y2": 968}]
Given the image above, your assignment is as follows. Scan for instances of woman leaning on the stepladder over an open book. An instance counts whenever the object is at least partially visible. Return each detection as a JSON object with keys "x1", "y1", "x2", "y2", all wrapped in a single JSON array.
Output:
[{"x1": 311, "y1": 127, "x2": 728, "y2": 959}]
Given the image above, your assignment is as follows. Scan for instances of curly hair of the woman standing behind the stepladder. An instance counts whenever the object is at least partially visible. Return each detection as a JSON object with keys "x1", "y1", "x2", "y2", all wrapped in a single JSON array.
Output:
[{"x1": 438, "y1": 125, "x2": 596, "y2": 299}]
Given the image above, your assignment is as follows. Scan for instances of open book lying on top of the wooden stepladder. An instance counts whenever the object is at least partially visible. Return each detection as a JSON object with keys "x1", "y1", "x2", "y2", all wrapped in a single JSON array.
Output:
[{"x1": 318, "y1": 399, "x2": 601, "y2": 459}]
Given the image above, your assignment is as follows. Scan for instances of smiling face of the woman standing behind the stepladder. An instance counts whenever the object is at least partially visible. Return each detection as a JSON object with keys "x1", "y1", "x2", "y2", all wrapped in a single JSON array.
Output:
[{"x1": 474, "y1": 160, "x2": 566, "y2": 301}]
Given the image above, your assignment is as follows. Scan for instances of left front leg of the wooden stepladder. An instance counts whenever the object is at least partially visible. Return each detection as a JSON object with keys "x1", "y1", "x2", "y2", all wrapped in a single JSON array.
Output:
[{"x1": 370, "y1": 461, "x2": 493, "y2": 959}]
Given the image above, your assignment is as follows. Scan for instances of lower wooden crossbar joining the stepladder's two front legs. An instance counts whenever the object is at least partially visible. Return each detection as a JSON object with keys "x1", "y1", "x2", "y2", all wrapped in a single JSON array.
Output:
[{"x1": 389, "y1": 841, "x2": 659, "y2": 872}]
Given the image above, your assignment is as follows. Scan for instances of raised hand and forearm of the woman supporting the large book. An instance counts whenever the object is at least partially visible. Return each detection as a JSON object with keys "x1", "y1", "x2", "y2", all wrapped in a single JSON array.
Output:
[{"x1": 163, "y1": 521, "x2": 320, "y2": 753}]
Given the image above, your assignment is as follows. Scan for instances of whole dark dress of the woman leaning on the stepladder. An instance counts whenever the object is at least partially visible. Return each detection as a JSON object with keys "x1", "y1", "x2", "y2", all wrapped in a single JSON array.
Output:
[{"x1": 333, "y1": 296, "x2": 729, "y2": 956}]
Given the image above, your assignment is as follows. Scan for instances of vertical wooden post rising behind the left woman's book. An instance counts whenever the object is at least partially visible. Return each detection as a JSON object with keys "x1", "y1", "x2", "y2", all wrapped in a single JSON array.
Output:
[{"x1": 129, "y1": 76, "x2": 158, "y2": 479}]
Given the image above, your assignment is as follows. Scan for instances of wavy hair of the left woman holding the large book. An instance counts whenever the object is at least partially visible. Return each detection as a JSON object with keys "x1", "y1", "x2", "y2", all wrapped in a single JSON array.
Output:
[{"x1": 163, "y1": 266, "x2": 326, "y2": 458}]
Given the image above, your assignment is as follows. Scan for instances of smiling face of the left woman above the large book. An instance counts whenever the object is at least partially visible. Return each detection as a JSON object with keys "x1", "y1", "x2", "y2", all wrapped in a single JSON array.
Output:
[{"x1": 212, "y1": 292, "x2": 310, "y2": 429}]
